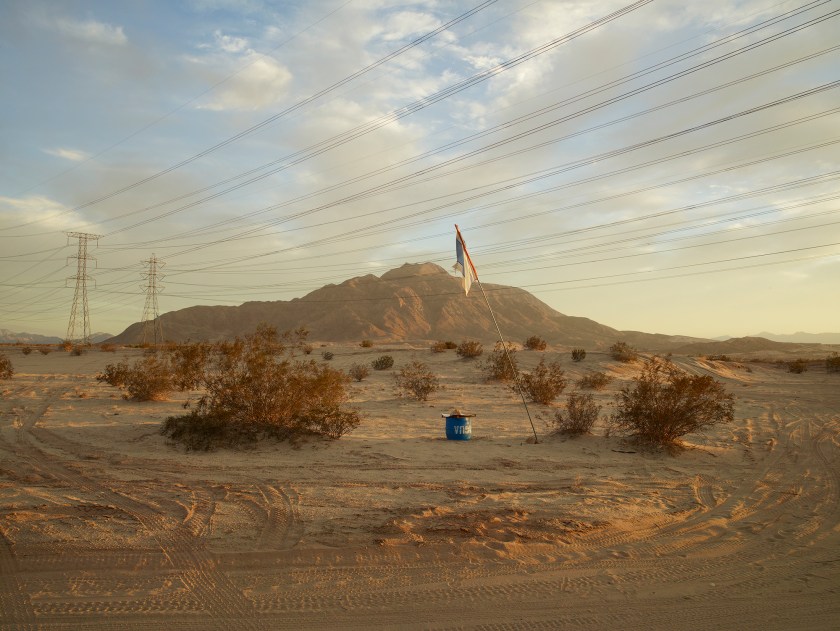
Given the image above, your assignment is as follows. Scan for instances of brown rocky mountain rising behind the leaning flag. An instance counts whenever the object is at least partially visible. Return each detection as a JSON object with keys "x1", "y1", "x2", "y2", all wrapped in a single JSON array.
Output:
[{"x1": 105, "y1": 263, "x2": 706, "y2": 351}]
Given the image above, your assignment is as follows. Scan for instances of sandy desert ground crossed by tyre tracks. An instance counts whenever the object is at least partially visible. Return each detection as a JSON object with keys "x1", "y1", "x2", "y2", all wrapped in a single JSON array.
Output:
[{"x1": 0, "y1": 343, "x2": 840, "y2": 631}]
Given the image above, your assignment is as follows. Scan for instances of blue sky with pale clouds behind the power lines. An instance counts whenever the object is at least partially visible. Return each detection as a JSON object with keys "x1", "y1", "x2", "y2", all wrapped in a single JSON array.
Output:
[{"x1": 0, "y1": 0, "x2": 840, "y2": 337}]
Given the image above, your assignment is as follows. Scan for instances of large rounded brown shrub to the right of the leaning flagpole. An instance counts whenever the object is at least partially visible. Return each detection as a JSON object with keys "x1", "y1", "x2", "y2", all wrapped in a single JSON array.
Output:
[{"x1": 611, "y1": 357, "x2": 735, "y2": 445}]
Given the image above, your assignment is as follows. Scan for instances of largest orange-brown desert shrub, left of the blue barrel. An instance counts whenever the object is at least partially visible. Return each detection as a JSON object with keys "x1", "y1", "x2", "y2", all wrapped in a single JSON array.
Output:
[{"x1": 161, "y1": 325, "x2": 360, "y2": 449}]
